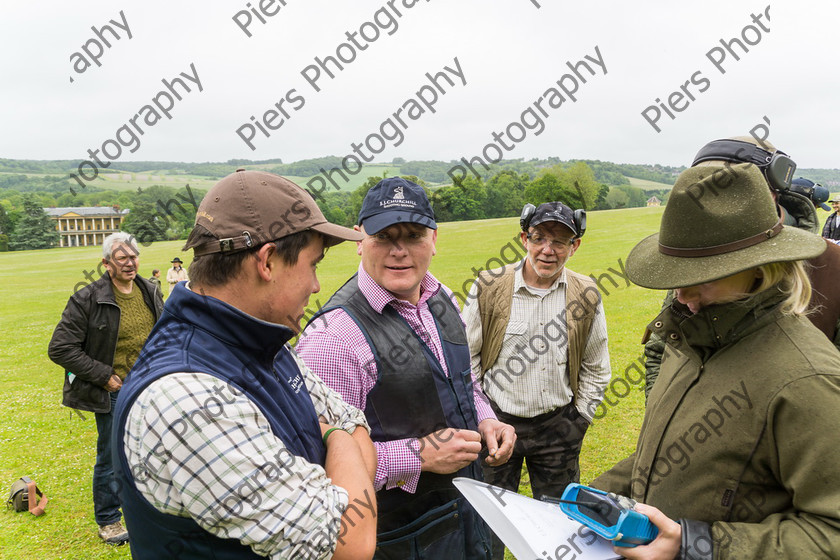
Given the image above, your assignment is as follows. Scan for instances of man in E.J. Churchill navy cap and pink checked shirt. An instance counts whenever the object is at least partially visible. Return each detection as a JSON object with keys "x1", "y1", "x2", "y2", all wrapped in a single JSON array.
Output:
[{"x1": 297, "y1": 177, "x2": 516, "y2": 560}]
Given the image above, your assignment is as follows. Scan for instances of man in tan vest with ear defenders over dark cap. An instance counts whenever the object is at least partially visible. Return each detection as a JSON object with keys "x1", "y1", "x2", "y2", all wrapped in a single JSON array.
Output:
[{"x1": 464, "y1": 202, "x2": 610, "y2": 558}]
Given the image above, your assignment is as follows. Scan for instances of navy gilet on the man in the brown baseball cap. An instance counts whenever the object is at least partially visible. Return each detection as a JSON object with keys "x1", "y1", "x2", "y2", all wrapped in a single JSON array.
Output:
[{"x1": 112, "y1": 284, "x2": 326, "y2": 560}]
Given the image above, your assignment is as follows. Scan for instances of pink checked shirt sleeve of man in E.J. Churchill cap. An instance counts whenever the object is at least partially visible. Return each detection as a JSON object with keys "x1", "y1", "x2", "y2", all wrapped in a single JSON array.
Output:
[{"x1": 296, "y1": 309, "x2": 421, "y2": 493}]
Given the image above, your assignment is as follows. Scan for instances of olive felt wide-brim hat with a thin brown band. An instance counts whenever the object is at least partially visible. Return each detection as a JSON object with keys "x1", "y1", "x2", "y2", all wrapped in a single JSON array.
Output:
[{"x1": 627, "y1": 163, "x2": 827, "y2": 290}]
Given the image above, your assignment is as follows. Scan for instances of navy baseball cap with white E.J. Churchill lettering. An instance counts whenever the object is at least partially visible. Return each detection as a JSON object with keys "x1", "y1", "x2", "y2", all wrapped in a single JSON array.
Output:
[{"x1": 358, "y1": 177, "x2": 437, "y2": 235}]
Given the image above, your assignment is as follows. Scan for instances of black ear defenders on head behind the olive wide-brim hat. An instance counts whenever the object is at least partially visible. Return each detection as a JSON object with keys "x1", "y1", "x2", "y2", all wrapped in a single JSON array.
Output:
[{"x1": 691, "y1": 139, "x2": 796, "y2": 191}]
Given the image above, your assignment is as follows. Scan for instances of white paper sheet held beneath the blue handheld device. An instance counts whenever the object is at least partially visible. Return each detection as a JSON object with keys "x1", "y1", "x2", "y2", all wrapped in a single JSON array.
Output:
[{"x1": 454, "y1": 477, "x2": 621, "y2": 560}]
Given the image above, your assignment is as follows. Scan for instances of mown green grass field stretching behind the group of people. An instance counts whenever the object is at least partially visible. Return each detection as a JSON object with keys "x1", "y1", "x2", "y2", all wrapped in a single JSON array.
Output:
[{"x1": 0, "y1": 208, "x2": 662, "y2": 560}]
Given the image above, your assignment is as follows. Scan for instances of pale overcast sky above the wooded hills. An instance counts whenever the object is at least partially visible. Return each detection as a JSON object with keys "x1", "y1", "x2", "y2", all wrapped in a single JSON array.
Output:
[{"x1": 0, "y1": 0, "x2": 840, "y2": 167}]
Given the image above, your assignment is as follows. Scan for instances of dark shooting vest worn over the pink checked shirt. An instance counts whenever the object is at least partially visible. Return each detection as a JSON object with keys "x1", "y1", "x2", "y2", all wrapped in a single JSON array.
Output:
[{"x1": 314, "y1": 275, "x2": 481, "y2": 535}]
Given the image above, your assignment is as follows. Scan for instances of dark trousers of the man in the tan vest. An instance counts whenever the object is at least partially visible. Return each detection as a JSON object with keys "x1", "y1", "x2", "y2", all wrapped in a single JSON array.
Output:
[{"x1": 482, "y1": 402, "x2": 589, "y2": 560}]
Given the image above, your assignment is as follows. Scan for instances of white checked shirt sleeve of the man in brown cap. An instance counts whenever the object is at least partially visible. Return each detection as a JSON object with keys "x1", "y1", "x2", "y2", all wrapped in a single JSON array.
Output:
[{"x1": 123, "y1": 373, "x2": 352, "y2": 560}]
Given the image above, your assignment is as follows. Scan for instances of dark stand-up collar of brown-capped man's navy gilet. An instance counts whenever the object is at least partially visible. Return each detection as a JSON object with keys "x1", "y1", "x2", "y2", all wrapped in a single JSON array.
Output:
[{"x1": 163, "y1": 283, "x2": 294, "y2": 360}]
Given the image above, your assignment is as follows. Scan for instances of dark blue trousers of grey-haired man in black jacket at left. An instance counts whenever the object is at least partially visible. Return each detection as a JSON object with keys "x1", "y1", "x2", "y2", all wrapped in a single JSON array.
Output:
[{"x1": 93, "y1": 391, "x2": 122, "y2": 526}]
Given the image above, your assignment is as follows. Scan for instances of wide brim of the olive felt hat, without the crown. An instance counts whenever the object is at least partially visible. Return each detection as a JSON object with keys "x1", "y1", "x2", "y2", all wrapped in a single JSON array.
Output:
[{"x1": 626, "y1": 227, "x2": 827, "y2": 290}]
